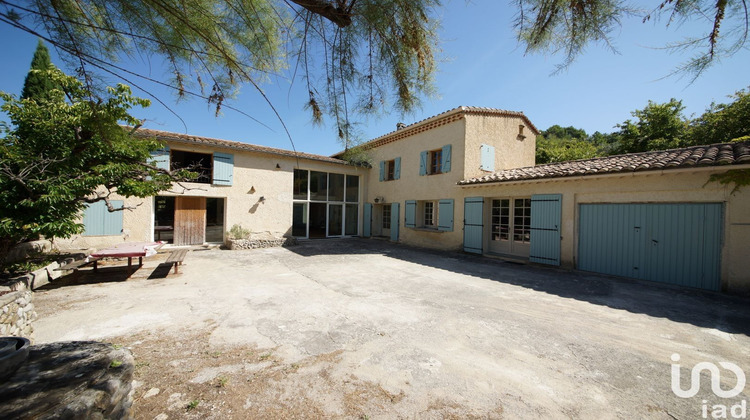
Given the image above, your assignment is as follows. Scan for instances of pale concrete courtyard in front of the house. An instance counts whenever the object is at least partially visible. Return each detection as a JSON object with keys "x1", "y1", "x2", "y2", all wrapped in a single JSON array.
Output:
[{"x1": 34, "y1": 239, "x2": 750, "y2": 419}]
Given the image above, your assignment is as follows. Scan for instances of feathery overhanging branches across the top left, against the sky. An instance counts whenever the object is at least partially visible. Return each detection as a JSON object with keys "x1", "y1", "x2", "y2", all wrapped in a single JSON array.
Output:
[{"x1": 0, "y1": 0, "x2": 439, "y2": 147}]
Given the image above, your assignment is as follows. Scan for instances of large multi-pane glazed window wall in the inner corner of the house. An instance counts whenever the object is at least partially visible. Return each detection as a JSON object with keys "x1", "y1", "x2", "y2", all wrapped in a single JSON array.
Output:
[{"x1": 292, "y1": 169, "x2": 359, "y2": 238}]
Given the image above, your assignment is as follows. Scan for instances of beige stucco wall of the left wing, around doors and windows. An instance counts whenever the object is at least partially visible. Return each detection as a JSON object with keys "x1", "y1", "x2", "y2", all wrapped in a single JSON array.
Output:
[{"x1": 56, "y1": 142, "x2": 367, "y2": 248}]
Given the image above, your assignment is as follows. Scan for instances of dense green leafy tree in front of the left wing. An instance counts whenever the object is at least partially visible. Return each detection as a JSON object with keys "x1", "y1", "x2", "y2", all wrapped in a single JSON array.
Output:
[{"x1": 0, "y1": 69, "x2": 187, "y2": 256}]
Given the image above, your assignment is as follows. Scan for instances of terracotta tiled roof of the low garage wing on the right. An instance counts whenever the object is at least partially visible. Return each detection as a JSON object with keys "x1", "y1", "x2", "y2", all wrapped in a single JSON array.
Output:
[{"x1": 458, "y1": 141, "x2": 750, "y2": 185}]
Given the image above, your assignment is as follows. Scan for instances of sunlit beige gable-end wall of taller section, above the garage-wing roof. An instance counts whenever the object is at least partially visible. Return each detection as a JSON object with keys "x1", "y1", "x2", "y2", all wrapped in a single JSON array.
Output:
[{"x1": 464, "y1": 115, "x2": 536, "y2": 179}]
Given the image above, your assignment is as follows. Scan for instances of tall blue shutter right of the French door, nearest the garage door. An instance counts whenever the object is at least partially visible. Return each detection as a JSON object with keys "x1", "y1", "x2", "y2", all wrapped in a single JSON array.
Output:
[{"x1": 529, "y1": 194, "x2": 562, "y2": 265}]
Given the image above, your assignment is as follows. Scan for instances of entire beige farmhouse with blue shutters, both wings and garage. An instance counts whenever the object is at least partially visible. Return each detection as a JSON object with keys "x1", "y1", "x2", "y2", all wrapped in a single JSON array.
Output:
[{"x1": 58, "y1": 107, "x2": 750, "y2": 294}]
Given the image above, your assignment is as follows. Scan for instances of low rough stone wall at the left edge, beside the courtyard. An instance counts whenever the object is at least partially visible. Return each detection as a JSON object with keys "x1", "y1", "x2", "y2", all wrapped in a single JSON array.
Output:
[{"x1": 0, "y1": 283, "x2": 36, "y2": 341}]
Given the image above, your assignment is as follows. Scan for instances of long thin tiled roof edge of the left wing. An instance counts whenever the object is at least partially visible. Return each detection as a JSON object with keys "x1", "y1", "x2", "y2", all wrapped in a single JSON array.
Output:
[{"x1": 135, "y1": 128, "x2": 348, "y2": 165}]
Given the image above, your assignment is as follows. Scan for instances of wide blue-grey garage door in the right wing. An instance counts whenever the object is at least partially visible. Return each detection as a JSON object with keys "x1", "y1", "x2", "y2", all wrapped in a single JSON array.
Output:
[{"x1": 578, "y1": 203, "x2": 723, "y2": 290}]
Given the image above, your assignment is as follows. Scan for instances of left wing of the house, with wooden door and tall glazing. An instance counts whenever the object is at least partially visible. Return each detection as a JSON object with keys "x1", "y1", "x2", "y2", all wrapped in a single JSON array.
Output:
[{"x1": 58, "y1": 129, "x2": 367, "y2": 248}]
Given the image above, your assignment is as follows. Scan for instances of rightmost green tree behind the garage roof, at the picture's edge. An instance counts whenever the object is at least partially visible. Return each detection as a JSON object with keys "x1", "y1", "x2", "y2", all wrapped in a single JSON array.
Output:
[{"x1": 688, "y1": 89, "x2": 750, "y2": 145}]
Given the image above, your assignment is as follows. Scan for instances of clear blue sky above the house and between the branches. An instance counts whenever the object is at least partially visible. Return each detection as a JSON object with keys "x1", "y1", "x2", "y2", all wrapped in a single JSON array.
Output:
[{"x1": 0, "y1": 0, "x2": 750, "y2": 155}]
